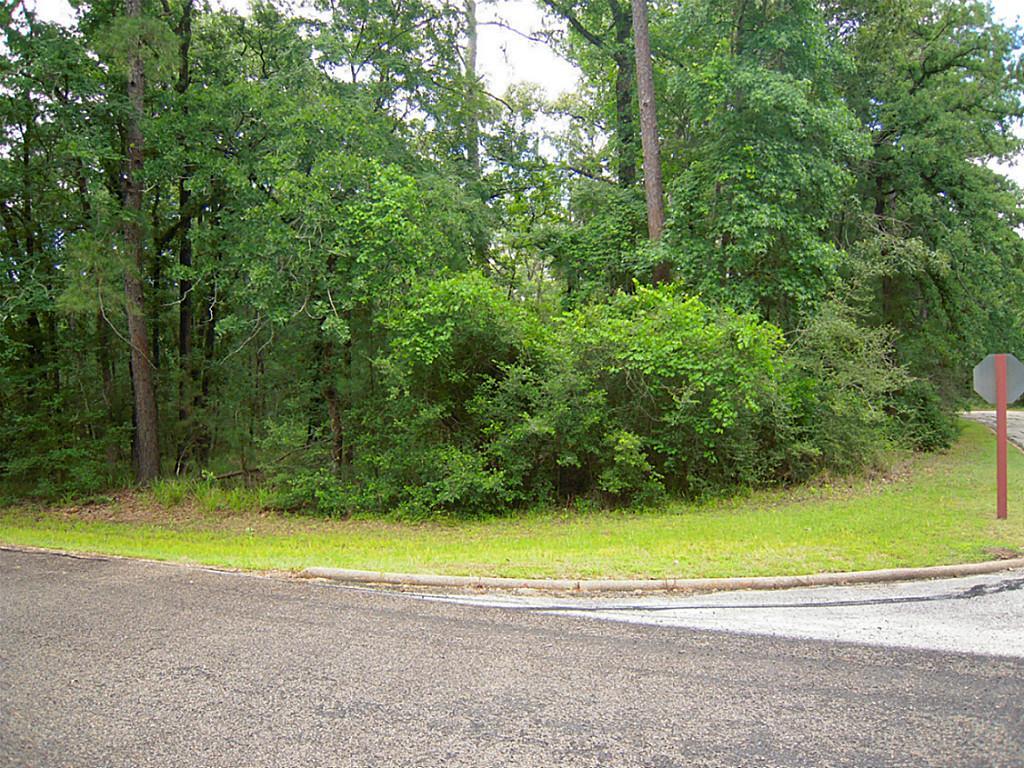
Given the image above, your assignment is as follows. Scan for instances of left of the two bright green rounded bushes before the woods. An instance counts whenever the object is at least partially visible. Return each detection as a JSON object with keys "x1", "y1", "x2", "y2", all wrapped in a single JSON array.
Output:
[{"x1": 351, "y1": 273, "x2": 550, "y2": 517}]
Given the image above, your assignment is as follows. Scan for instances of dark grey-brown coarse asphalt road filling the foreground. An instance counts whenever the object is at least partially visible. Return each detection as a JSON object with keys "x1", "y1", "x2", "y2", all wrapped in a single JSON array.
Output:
[{"x1": 0, "y1": 551, "x2": 1024, "y2": 768}]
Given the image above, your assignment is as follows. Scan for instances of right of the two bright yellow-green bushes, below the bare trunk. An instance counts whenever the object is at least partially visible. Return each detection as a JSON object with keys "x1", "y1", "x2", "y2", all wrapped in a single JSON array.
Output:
[{"x1": 560, "y1": 288, "x2": 782, "y2": 495}]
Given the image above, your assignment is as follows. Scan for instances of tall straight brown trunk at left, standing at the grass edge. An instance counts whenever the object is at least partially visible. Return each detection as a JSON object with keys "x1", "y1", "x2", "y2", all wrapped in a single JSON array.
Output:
[{"x1": 124, "y1": 0, "x2": 160, "y2": 482}]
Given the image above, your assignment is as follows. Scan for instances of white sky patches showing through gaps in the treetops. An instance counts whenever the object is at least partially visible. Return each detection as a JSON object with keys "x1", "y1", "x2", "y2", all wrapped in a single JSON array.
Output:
[{"x1": 22, "y1": 0, "x2": 1024, "y2": 185}]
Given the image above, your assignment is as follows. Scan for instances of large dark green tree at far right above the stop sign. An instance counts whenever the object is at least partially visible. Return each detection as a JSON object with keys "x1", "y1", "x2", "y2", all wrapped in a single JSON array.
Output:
[{"x1": 827, "y1": 0, "x2": 1024, "y2": 395}]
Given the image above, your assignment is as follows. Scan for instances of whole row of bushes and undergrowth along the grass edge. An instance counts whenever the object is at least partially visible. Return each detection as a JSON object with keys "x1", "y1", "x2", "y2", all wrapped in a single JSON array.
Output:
[{"x1": 282, "y1": 273, "x2": 934, "y2": 519}]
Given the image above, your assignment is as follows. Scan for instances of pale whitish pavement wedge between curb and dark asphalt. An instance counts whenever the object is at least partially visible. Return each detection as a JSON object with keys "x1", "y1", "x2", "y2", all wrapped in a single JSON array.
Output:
[{"x1": 425, "y1": 570, "x2": 1024, "y2": 659}]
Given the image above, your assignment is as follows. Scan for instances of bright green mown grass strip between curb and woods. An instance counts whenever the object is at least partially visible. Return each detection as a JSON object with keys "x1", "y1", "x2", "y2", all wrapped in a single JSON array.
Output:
[{"x1": 0, "y1": 424, "x2": 1024, "y2": 578}]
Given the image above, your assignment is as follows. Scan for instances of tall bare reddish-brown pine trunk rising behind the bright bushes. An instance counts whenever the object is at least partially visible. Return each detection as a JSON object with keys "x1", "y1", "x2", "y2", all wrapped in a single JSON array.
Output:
[{"x1": 633, "y1": 0, "x2": 672, "y2": 283}]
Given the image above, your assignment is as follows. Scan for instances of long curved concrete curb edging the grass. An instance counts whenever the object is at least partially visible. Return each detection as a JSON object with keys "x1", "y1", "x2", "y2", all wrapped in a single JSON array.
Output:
[{"x1": 298, "y1": 557, "x2": 1024, "y2": 592}]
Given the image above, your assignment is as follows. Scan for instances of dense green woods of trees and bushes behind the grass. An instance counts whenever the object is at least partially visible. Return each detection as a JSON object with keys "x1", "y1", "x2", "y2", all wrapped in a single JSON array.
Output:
[{"x1": 0, "y1": 0, "x2": 1024, "y2": 516}]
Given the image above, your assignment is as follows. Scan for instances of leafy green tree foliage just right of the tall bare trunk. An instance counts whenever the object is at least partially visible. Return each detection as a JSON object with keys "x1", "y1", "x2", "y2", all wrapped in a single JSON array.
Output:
[{"x1": 667, "y1": 0, "x2": 868, "y2": 329}]
